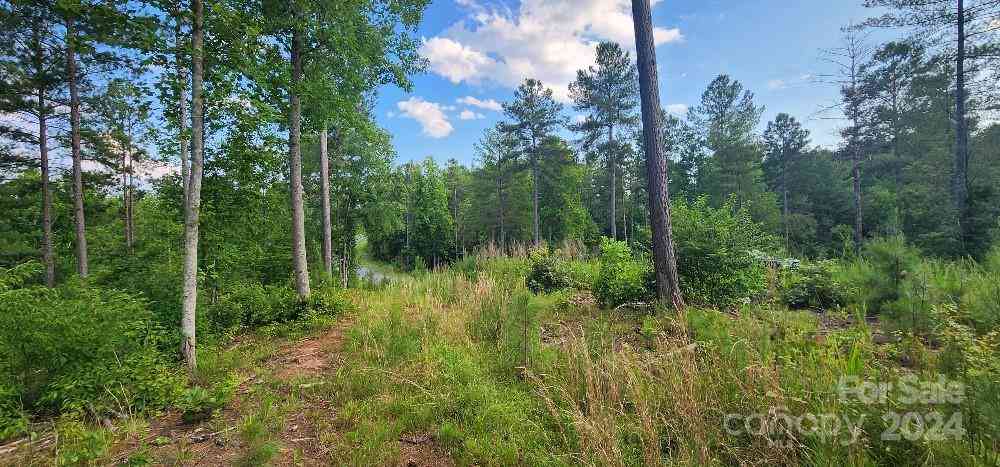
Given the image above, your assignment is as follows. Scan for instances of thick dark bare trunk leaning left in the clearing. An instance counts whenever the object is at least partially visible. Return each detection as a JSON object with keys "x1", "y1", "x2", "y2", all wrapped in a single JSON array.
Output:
[{"x1": 632, "y1": 0, "x2": 684, "y2": 311}]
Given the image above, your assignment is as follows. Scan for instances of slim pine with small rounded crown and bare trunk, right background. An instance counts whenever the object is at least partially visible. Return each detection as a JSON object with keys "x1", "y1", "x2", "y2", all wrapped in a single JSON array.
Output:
[{"x1": 764, "y1": 113, "x2": 809, "y2": 249}]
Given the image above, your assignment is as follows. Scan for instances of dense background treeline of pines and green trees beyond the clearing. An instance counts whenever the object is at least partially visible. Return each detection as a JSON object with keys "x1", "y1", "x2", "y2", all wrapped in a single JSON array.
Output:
[{"x1": 376, "y1": 34, "x2": 1000, "y2": 264}]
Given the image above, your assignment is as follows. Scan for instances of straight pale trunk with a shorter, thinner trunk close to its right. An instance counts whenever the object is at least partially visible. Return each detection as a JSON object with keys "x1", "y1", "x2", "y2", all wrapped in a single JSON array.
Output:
[{"x1": 288, "y1": 23, "x2": 309, "y2": 300}]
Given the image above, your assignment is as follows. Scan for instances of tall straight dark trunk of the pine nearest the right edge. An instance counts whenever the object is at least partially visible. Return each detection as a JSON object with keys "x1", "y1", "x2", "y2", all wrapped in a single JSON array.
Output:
[{"x1": 951, "y1": 0, "x2": 969, "y2": 248}]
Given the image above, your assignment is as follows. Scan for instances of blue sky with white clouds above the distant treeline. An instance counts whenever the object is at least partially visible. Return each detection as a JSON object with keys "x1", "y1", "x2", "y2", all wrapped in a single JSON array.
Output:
[{"x1": 375, "y1": 0, "x2": 900, "y2": 164}]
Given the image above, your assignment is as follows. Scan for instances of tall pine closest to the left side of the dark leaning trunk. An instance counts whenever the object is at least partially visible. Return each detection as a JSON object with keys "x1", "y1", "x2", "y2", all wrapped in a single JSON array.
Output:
[{"x1": 569, "y1": 42, "x2": 639, "y2": 238}]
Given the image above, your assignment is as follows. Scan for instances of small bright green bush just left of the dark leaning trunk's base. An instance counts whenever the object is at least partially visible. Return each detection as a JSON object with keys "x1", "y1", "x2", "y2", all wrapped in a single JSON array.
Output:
[{"x1": 593, "y1": 238, "x2": 653, "y2": 307}]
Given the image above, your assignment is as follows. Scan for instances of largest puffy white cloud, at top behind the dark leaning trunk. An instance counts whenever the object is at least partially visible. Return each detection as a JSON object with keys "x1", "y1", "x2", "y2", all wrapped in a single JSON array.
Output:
[{"x1": 420, "y1": 0, "x2": 683, "y2": 101}]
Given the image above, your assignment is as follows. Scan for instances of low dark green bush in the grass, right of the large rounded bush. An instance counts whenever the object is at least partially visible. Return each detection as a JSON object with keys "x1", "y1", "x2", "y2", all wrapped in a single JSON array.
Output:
[{"x1": 781, "y1": 261, "x2": 847, "y2": 310}]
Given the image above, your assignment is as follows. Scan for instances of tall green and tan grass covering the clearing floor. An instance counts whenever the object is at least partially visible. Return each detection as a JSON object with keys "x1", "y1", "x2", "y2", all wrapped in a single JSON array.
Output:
[{"x1": 9, "y1": 254, "x2": 1000, "y2": 466}]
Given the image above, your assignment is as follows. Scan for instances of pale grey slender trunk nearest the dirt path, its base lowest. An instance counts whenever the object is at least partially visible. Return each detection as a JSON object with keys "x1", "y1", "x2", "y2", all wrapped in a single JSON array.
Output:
[{"x1": 181, "y1": 0, "x2": 205, "y2": 372}]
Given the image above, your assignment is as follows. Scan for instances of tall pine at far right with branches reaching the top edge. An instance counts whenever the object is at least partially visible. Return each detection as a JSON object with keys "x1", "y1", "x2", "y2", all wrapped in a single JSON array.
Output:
[{"x1": 863, "y1": 0, "x2": 1000, "y2": 252}]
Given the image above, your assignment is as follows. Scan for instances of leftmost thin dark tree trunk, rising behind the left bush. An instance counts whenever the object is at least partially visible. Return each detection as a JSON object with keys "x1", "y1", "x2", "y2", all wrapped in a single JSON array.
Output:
[{"x1": 32, "y1": 19, "x2": 56, "y2": 287}]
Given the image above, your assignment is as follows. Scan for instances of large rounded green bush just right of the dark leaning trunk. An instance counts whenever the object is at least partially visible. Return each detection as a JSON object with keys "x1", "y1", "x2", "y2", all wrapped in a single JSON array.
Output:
[{"x1": 671, "y1": 198, "x2": 773, "y2": 307}]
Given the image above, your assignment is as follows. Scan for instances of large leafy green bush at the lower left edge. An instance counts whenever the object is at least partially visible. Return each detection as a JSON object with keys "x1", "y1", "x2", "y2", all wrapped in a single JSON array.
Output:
[{"x1": 0, "y1": 266, "x2": 184, "y2": 431}]
